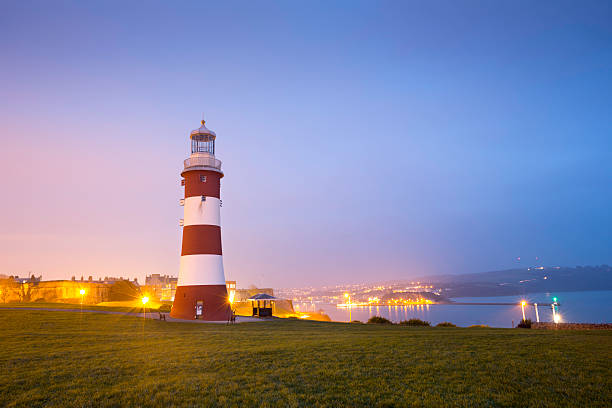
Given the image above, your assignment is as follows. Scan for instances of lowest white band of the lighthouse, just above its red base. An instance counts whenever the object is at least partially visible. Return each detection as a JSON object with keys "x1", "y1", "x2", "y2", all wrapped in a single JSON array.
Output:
[{"x1": 176, "y1": 254, "x2": 225, "y2": 286}]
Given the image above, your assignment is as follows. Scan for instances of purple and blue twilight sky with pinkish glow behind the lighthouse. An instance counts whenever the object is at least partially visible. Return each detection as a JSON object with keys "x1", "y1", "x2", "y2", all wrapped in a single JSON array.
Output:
[{"x1": 0, "y1": 1, "x2": 612, "y2": 287}]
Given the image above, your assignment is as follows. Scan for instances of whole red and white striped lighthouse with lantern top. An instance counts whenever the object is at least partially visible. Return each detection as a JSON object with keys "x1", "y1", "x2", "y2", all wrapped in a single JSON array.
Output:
[{"x1": 170, "y1": 120, "x2": 231, "y2": 320}]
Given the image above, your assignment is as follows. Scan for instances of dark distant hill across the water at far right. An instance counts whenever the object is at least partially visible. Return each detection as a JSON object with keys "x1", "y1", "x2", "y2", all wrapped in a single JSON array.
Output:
[{"x1": 420, "y1": 265, "x2": 612, "y2": 298}]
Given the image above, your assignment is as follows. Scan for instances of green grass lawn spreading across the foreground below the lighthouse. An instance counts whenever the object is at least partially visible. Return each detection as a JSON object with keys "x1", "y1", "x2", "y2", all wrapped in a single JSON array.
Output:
[{"x1": 0, "y1": 309, "x2": 612, "y2": 407}]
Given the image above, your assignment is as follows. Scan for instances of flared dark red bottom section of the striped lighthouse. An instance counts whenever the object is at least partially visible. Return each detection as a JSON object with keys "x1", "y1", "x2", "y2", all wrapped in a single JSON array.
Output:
[{"x1": 170, "y1": 285, "x2": 232, "y2": 321}]
